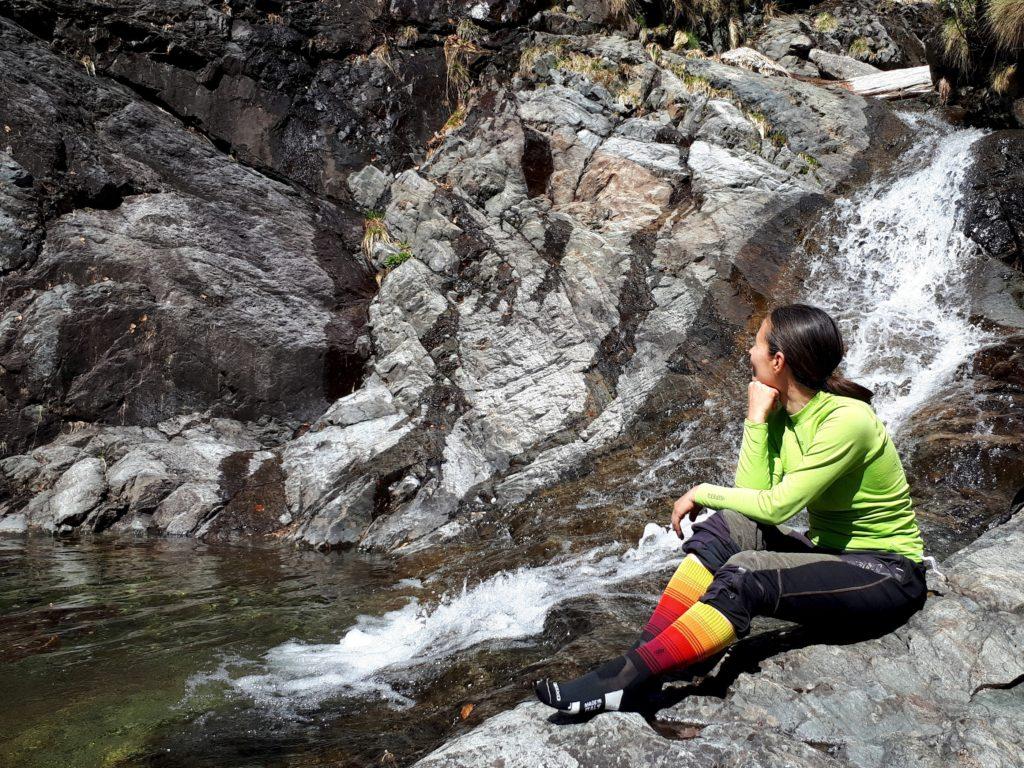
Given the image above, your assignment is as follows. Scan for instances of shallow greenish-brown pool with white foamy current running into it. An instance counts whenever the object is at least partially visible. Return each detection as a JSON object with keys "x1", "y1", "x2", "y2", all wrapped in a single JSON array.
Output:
[{"x1": 0, "y1": 526, "x2": 673, "y2": 768}]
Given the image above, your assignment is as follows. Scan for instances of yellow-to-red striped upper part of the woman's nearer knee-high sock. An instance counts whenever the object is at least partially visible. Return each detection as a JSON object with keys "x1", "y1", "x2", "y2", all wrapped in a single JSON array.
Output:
[{"x1": 635, "y1": 602, "x2": 736, "y2": 675}]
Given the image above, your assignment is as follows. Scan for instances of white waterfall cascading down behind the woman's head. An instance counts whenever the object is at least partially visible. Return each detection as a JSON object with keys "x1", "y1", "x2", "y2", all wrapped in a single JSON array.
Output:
[{"x1": 803, "y1": 114, "x2": 987, "y2": 432}]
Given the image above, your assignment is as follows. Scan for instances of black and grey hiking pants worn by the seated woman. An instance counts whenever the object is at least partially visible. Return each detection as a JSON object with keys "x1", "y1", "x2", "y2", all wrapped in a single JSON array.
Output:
[{"x1": 683, "y1": 509, "x2": 928, "y2": 637}]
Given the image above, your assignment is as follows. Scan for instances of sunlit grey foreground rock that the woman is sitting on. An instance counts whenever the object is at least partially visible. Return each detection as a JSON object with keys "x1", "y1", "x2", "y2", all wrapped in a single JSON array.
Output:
[{"x1": 417, "y1": 512, "x2": 1024, "y2": 768}]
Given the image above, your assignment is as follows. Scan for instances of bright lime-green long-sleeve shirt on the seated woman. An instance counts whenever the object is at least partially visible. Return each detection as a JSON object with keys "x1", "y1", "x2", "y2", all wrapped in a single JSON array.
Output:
[{"x1": 694, "y1": 391, "x2": 924, "y2": 562}]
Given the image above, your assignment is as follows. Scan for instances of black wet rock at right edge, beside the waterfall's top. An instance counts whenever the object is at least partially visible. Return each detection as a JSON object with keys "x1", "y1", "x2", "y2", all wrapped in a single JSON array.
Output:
[{"x1": 964, "y1": 130, "x2": 1024, "y2": 270}]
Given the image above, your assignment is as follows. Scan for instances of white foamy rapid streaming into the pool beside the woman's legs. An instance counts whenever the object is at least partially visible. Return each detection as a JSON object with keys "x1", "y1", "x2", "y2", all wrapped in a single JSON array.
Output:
[{"x1": 219, "y1": 520, "x2": 692, "y2": 711}]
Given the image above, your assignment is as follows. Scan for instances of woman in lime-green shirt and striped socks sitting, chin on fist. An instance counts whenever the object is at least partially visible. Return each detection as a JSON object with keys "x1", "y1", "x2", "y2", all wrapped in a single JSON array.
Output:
[{"x1": 535, "y1": 304, "x2": 927, "y2": 714}]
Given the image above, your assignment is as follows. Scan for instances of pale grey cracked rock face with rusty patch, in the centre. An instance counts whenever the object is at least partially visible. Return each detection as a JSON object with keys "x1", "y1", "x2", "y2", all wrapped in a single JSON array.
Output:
[{"x1": 354, "y1": 36, "x2": 880, "y2": 548}]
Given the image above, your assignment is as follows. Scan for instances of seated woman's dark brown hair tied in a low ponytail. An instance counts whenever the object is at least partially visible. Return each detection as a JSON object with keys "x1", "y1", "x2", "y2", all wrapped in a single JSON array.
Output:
[{"x1": 768, "y1": 304, "x2": 873, "y2": 402}]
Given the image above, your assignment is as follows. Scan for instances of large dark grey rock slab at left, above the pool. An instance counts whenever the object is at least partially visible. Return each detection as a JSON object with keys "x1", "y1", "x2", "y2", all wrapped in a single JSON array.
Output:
[{"x1": 0, "y1": 20, "x2": 373, "y2": 451}]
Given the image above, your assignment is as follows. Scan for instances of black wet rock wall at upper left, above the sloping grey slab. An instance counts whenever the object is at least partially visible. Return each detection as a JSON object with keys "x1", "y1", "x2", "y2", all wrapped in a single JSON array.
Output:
[{"x1": 4, "y1": 0, "x2": 464, "y2": 200}]
